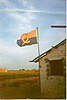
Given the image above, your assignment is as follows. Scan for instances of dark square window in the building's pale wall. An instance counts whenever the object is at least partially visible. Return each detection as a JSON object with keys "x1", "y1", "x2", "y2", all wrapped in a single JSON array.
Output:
[{"x1": 50, "y1": 60, "x2": 64, "y2": 76}]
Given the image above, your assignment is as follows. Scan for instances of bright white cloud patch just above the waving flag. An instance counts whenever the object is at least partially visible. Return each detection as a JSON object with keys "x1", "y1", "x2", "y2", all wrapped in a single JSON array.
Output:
[{"x1": 7, "y1": 12, "x2": 36, "y2": 37}]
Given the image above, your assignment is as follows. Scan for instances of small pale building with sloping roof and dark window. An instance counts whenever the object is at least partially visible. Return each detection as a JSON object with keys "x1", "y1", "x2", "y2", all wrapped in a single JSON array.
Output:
[{"x1": 30, "y1": 39, "x2": 66, "y2": 99}]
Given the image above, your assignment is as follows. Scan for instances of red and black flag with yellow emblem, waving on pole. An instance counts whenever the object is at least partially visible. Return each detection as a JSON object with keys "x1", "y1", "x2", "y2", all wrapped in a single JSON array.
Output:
[{"x1": 17, "y1": 30, "x2": 37, "y2": 47}]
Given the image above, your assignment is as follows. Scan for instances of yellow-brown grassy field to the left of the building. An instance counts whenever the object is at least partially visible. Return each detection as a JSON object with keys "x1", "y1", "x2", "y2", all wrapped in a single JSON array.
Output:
[{"x1": 0, "y1": 70, "x2": 41, "y2": 99}]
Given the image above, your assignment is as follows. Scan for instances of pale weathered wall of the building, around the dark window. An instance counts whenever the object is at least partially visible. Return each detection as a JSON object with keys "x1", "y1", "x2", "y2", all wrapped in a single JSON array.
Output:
[{"x1": 40, "y1": 41, "x2": 66, "y2": 98}]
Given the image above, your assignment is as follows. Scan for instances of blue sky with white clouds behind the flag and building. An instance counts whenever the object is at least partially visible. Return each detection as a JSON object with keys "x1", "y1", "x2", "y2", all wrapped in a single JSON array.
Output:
[{"x1": 0, "y1": 0, "x2": 66, "y2": 70}]
